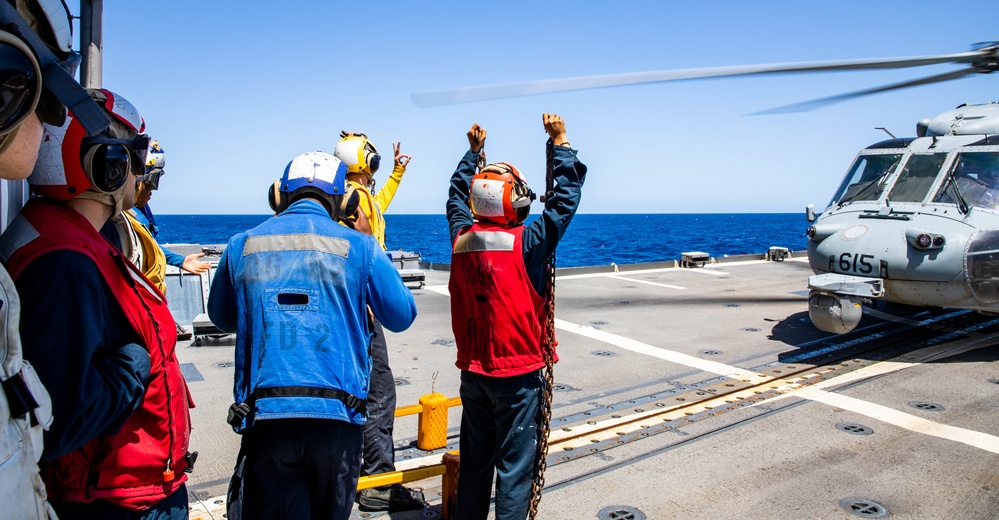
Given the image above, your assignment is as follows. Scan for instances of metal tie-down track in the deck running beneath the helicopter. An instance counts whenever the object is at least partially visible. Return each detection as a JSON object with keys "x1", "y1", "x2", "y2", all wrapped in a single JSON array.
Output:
[{"x1": 397, "y1": 311, "x2": 999, "y2": 476}]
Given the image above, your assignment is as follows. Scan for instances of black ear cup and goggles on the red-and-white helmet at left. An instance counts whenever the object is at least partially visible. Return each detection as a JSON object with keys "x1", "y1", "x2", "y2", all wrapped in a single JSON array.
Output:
[{"x1": 81, "y1": 134, "x2": 149, "y2": 192}]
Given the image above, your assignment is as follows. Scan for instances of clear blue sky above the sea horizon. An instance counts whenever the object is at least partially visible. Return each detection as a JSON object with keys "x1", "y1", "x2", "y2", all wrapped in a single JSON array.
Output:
[{"x1": 90, "y1": 0, "x2": 999, "y2": 214}]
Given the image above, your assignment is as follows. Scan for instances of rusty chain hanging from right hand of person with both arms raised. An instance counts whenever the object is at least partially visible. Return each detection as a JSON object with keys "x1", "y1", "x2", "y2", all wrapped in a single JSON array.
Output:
[{"x1": 527, "y1": 139, "x2": 555, "y2": 520}]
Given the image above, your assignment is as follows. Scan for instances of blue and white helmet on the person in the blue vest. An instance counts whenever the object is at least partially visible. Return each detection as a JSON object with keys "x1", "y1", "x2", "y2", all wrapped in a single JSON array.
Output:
[{"x1": 278, "y1": 152, "x2": 347, "y2": 218}]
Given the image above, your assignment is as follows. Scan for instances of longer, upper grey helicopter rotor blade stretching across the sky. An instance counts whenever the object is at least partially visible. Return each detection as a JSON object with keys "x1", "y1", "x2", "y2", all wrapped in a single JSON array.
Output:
[{"x1": 411, "y1": 45, "x2": 999, "y2": 108}]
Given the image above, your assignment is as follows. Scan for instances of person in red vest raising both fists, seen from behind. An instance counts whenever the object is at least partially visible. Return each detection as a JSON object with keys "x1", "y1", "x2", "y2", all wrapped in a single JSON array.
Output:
[{"x1": 447, "y1": 114, "x2": 586, "y2": 520}]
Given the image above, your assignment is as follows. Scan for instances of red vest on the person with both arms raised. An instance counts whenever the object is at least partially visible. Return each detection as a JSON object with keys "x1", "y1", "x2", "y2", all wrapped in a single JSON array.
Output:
[{"x1": 448, "y1": 222, "x2": 558, "y2": 377}]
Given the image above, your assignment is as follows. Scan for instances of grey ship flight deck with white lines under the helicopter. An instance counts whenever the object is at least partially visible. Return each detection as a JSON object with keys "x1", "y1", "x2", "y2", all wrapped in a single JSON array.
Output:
[{"x1": 174, "y1": 253, "x2": 999, "y2": 519}]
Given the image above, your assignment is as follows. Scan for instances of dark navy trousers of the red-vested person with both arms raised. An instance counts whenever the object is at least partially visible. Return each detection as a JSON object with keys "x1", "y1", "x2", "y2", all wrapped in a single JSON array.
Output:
[{"x1": 454, "y1": 370, "x2": 545, "y2": 520}]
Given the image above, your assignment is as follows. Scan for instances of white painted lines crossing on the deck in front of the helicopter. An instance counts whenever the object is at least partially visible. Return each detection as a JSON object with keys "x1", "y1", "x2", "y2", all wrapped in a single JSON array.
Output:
[{"x1": 555, "y1": 319, "x2": 999, "y2": 453}]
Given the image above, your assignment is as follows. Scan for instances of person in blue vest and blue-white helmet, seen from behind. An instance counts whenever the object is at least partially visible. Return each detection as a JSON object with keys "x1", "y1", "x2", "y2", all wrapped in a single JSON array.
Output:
[{"x1": 208, "y1": 152, "x2": 416, "y2": 519}]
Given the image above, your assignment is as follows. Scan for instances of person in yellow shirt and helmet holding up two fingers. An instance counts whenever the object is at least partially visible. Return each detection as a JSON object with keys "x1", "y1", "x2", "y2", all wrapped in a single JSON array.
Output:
[{"x1": 333, "y1": 132, "x2": 424, "y2": 511}]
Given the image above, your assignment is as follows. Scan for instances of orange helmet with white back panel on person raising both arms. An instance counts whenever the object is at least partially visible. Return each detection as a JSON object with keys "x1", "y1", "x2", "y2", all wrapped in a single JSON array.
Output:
[{"x1": 468, "y1": 163, "x2": 535, "y2": 226}]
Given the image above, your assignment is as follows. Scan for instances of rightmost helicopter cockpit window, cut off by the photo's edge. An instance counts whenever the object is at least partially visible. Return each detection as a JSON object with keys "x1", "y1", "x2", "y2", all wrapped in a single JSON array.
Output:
[{"x1": 933, "y1": 152, "x2": 999, "y2": 209}]
